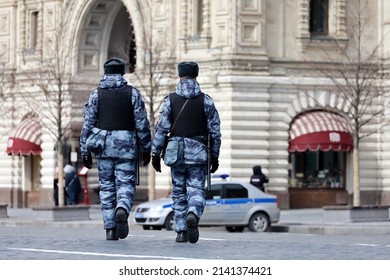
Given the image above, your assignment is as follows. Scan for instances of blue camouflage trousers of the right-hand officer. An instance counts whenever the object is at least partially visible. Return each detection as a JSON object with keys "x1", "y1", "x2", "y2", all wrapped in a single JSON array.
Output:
[{"x1": 171, "y1": 164, "x2": 207, "y2": 232}]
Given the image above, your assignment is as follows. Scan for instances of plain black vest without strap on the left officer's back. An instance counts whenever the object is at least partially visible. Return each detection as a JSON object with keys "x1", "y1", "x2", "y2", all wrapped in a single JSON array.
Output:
[{"x1": 97, "y1": 85, "x2": 135, "y2": 131}]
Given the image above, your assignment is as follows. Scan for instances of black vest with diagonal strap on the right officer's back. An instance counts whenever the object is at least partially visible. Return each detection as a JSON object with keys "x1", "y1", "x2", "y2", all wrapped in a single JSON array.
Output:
[{"x1": 169, "y1": 92, "x2": 207, "y2": 137}]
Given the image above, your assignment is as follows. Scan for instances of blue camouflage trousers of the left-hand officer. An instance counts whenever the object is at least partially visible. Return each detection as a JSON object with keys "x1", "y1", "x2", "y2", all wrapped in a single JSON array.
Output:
[{"x1": 97, "y1": 158, "x2": 135, "y2": 229}]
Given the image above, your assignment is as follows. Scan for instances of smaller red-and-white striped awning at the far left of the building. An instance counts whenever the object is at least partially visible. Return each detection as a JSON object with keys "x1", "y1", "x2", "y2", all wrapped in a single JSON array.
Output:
[{"x1": 7, "y1": 117, "x2": 42, "y2": 156}]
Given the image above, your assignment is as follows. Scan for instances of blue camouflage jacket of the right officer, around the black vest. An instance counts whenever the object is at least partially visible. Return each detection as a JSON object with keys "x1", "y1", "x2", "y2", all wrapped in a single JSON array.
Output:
[{"x1": 152, "y1": 80, "x2": 221, "y2": 164}]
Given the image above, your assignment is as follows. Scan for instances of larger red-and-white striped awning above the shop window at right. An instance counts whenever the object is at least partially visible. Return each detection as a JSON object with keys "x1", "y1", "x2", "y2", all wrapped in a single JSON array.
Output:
[{"x1": 289, "y1": 111, "x2": 353, "y2": 152}]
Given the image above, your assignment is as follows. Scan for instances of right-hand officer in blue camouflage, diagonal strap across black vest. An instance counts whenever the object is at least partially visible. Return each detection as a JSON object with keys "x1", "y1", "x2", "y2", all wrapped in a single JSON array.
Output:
[{"x1": 152, "y1": 62, "x2": 221, "y2": 243}]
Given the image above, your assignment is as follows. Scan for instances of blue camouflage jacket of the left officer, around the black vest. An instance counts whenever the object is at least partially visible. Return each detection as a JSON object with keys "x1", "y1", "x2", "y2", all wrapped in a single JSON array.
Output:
[{"x1": 80, "y1": 75, "x2": 151, "y2": 159}]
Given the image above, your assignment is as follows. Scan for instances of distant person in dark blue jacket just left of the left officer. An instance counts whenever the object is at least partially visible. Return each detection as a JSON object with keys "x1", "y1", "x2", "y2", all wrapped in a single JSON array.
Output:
[{"x1": 64, "y1": 164, "x2": 81, "y2": 205}]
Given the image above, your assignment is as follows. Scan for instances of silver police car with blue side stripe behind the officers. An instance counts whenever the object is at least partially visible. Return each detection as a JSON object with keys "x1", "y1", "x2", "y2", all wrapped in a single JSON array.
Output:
[{"x1": 133, "y1": 176, "x2": 280, "y2": 232}]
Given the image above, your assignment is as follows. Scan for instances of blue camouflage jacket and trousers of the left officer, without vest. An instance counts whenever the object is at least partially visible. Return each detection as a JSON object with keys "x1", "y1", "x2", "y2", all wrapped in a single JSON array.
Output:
[{"x1": 80, "y1": 74, "x2": 151, "y2": 229}]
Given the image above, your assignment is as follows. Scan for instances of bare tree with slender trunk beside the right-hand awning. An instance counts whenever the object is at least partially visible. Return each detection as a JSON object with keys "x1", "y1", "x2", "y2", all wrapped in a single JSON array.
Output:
[{"x1": 298, "y1": 0, "x2": 389, "y2": 206}]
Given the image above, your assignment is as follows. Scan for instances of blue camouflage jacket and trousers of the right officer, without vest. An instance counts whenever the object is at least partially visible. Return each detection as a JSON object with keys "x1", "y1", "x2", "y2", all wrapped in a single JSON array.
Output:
[{"x1": 152, "y1": 79, "x2": 221, "y2": 233}]
